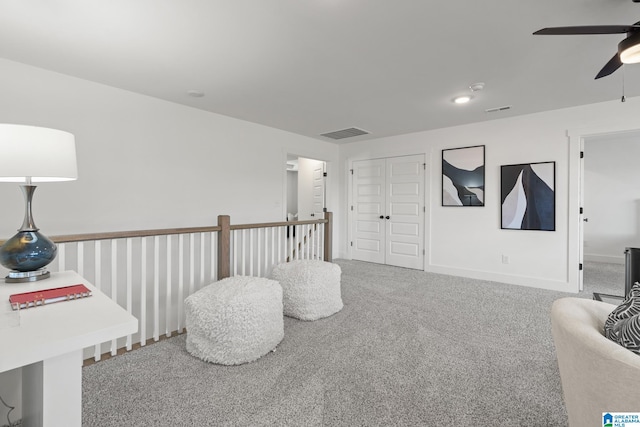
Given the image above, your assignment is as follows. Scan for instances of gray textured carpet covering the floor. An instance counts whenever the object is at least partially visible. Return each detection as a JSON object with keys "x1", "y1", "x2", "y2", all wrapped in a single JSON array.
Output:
[{"x1": 83, "y1": 260, "x2": 624, "y2": 427}]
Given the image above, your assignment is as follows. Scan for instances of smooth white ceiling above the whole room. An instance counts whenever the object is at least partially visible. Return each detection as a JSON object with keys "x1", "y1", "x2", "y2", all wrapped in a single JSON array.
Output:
[{"x1": 0, "y1": 0, "x2": 640, "y2": 142}]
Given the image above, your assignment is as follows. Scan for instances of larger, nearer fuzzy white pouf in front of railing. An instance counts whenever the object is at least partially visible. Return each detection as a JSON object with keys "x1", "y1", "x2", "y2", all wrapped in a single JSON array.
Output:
[{"x1": 184, "y1": 276, "x2": 284, "y2": 365}]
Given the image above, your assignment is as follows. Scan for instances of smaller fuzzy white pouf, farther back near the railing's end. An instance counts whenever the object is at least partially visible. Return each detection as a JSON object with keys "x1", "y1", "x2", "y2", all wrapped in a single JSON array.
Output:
[{"x1": 272, "y1": 260, "x2": 343, "y2": 320}]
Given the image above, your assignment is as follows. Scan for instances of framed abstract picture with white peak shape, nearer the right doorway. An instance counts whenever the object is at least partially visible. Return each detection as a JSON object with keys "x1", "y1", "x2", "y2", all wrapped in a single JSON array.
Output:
[{"x1": 500, "y1": 162, "x2": 556, "y2": 231}]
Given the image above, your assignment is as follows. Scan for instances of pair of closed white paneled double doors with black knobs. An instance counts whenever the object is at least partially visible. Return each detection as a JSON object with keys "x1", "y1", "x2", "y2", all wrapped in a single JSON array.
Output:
[{"x1": 351, "y1": 155, "x2": 425, "y2": 270}]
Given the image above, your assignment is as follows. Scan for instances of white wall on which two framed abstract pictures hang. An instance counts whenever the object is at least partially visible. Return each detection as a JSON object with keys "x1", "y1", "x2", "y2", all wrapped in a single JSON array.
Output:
[{"x1": 339, "y1": 98, "x2": 640, "y2": 292}]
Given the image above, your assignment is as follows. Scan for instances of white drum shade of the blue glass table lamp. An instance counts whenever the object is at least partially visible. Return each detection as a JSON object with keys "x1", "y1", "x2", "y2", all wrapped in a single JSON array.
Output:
[{"x1": 0, "y1": 124, "x2": 78, "y2": 182}]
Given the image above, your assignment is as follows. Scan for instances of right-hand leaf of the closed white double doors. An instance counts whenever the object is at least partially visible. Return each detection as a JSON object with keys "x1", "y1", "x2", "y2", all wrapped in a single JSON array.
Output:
[{"x1": 385, "y1": 155, "x2": 425, "y2": 270}]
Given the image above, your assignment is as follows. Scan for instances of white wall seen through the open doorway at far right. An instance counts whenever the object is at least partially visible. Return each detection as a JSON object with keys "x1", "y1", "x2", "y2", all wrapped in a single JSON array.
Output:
[{"x1": 584, "y1": 133, "x2": 640, "y2": 264}]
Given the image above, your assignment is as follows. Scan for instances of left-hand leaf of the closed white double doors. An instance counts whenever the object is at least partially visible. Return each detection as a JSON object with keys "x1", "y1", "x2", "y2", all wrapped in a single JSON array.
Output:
[{"x1": 351, "y1": 159, "x2": 386, "y2": 264}]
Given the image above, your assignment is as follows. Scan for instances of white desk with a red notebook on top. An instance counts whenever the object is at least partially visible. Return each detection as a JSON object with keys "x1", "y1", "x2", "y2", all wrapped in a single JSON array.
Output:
[{"x1": 0, "y1": 271, "x2": 138, "y2": 427}]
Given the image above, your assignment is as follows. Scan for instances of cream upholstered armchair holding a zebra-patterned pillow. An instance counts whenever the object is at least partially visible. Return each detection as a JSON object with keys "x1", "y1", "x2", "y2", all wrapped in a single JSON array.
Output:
[{"x1": 551, "y1": 298, "x2": 640, "y2": 427}]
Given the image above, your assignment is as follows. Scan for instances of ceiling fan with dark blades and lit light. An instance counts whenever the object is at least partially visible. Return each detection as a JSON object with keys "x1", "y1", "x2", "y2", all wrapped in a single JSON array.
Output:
[{"x1": 533, "y1": 0, "x2": 640, "y2": 79}]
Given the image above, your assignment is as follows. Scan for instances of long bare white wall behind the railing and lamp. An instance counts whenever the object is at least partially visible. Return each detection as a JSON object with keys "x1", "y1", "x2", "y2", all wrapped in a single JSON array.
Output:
[{"x1": 0, "y1": 59, "x2": 338, "y2": 238}]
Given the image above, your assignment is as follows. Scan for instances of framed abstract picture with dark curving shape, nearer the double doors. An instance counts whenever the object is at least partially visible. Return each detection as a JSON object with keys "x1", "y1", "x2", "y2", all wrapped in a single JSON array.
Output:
[{"x1": 442, "y1": 145, "x2": 484, "y2": 206}]
